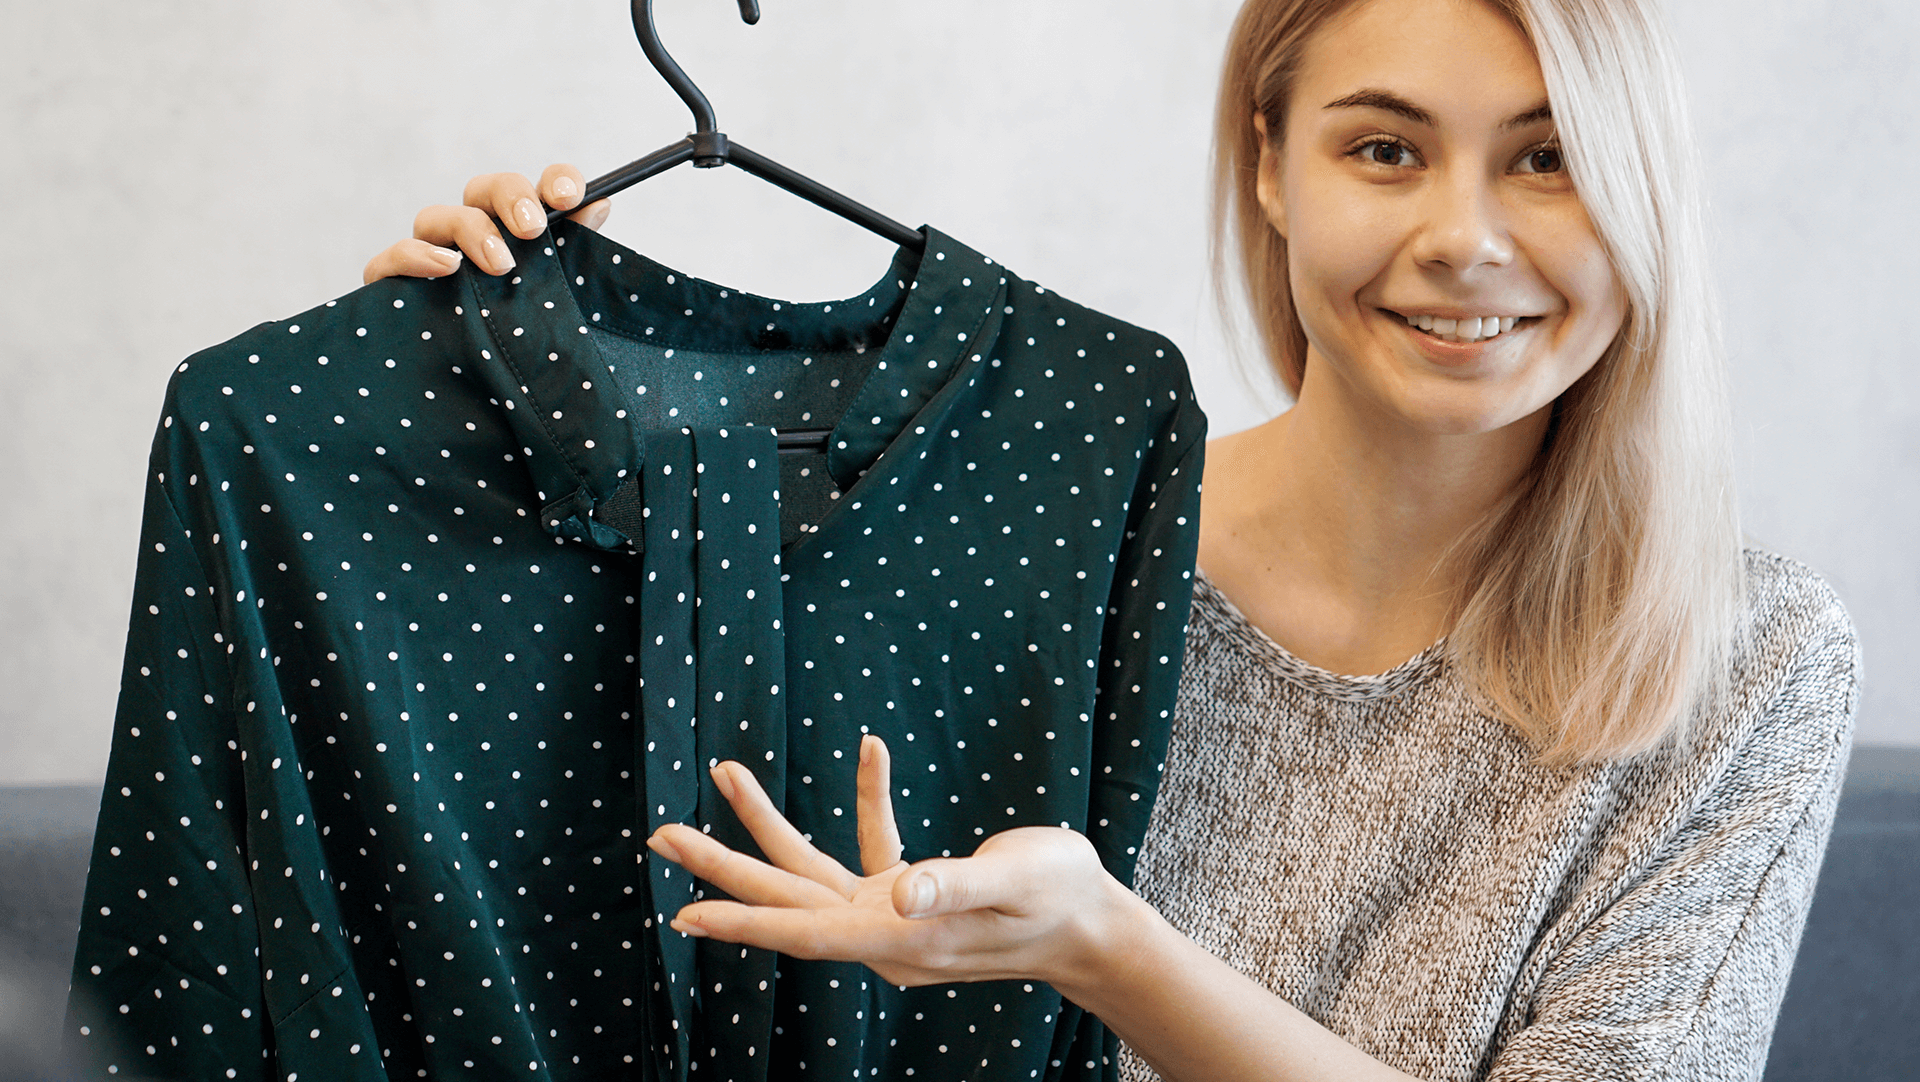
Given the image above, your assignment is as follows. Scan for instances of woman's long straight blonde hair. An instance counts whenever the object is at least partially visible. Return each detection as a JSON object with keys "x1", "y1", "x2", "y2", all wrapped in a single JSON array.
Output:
[{"x1": 1213, "y1": 0, "x2": 1743, "y2": 767}]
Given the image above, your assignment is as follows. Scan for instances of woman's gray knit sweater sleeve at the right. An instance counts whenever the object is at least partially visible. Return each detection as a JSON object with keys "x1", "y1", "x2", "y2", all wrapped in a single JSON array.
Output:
[{"x1": 1488, "y1": 576, "x2": 1859, "y2": 1082}]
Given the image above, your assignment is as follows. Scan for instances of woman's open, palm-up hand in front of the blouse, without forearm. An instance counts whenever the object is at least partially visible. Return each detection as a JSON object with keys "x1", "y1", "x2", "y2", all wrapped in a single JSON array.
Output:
[{"x1": 647, "y1": 737, "x2": 1146, "y2": 998}]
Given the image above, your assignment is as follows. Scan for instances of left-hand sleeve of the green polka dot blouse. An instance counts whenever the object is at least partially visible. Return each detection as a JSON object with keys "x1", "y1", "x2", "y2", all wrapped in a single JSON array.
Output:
[{"x1": 65, "y1": 431, "x2": 273, "y2": 1080}]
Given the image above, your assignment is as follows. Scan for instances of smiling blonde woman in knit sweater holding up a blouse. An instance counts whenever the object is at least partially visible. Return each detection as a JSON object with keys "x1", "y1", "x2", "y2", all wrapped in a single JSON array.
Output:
[{"x1": 367, "y1": 0, "x2": 1857, "y2": 1080}]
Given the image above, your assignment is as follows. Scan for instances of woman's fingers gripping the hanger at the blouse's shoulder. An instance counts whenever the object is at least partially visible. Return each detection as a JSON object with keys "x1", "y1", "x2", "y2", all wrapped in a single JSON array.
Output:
[{"x1": 361, "y1": 165, "x2": 612, "y2": 282}]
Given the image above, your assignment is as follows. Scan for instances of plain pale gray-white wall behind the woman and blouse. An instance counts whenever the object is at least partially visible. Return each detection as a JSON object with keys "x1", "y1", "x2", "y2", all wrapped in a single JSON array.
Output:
[{"x1": 0, "y1": 0, "x2": 1920, "y2": 783}]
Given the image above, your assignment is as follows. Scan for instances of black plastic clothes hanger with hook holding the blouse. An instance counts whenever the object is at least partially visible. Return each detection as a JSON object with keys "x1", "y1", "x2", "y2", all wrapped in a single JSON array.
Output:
[{"x1": 560, "y1": 0, "x2": 927, "y2": 455}]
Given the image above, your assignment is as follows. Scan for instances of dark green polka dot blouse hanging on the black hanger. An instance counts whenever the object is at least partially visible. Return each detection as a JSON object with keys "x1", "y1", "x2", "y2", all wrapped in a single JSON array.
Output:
[{"x1": 69, "y1": 223, "x2": 1204, "y2": 1082}]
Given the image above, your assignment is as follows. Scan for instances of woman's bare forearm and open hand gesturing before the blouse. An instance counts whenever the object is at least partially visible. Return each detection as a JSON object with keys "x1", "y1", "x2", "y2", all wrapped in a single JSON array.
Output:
[{"x1": 647, "y1": 737, "x2": 1409, "y2": 1082}]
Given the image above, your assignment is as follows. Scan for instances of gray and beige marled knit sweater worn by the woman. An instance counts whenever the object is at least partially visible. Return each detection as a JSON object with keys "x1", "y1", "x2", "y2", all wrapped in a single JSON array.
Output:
[{"x1": 1121, "y1": 551, "x2": 1859, "y2": 1082}]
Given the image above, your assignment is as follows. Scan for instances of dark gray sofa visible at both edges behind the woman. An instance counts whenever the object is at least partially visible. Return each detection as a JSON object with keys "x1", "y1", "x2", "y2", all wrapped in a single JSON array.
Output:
[{"x1": 0, "y1": 744, "x2": 1920, "y2": 1082}]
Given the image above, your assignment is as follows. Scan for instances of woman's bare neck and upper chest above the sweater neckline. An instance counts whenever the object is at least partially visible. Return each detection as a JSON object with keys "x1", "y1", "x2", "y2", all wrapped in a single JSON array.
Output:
[{"x1": 1200, "y1": 372, "x2": 1546, "y2": 673}]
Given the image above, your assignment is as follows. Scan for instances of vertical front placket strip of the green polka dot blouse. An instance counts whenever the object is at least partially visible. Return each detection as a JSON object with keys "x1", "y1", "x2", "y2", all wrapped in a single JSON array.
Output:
[{"x1": 636, "y1": 428, "x2": 787, "y2": 1078}]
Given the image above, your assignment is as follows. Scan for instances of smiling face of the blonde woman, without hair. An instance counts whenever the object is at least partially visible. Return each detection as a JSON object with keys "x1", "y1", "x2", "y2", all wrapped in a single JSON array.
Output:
[{"x1": 1256, "y1": 0, "x2": 1626, "y2": 435}]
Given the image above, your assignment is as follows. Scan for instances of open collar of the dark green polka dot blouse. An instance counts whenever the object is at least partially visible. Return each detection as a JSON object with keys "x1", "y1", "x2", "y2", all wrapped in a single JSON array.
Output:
[{"x1": 461, "y1": 219, "x2": 1006, "y2": 549}]
